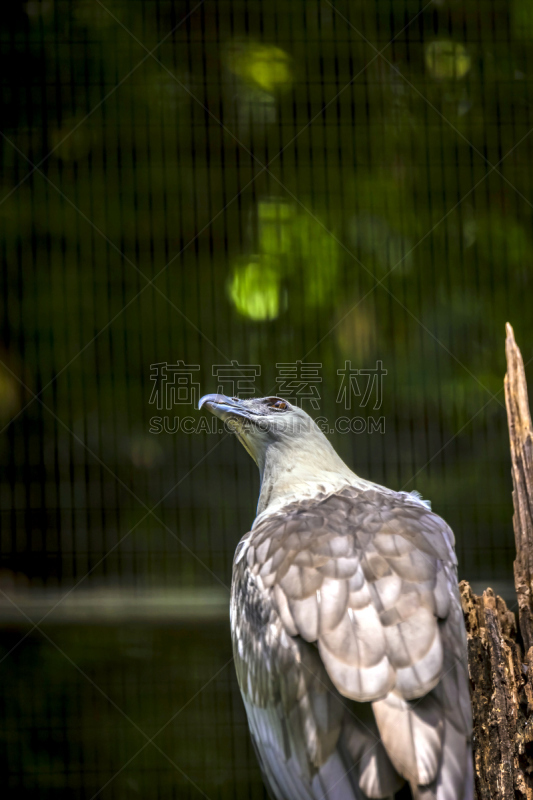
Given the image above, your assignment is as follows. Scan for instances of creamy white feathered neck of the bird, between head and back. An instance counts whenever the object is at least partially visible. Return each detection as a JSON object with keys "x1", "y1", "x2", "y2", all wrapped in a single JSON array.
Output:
[{"x1": 254, "y1": 437, "x2": 366, "y2": 524}]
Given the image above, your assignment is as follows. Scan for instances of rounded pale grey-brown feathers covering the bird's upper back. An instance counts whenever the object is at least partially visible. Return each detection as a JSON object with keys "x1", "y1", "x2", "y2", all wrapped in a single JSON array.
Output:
[{"x1": 246, "y1": 484, "x2": 454, "y2": 701}]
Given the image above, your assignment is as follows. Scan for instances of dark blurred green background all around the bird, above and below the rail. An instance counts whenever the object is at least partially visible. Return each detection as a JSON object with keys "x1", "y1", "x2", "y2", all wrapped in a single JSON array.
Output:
[{"x1": 0, "y1": 0, "x2": 533, "y2": 800}]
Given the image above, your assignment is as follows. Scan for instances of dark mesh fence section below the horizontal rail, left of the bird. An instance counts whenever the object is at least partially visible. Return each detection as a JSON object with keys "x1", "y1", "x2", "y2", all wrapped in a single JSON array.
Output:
[{"x1": 0, "y1": 626, "x2": 266, "y2": 800}]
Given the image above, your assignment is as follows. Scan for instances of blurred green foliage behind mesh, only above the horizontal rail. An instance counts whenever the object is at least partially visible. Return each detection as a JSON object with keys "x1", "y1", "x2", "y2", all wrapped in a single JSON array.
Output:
[{"x1": 0, "y1": 0, "x2": 533, "y2": 582}]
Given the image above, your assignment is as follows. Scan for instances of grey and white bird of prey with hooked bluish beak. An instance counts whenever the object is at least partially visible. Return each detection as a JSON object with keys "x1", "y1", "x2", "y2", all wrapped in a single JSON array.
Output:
[{"x1": 199, "y1": 394, "x2": 474, "y2": 800}]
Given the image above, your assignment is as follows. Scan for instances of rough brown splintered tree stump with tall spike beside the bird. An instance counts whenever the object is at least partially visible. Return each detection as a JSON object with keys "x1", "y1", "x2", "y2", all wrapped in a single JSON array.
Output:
[{"x1": 460, "y1": 324, "x2": 533, "y2": 800}]
